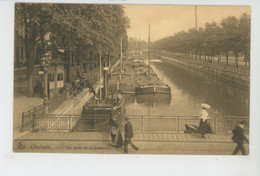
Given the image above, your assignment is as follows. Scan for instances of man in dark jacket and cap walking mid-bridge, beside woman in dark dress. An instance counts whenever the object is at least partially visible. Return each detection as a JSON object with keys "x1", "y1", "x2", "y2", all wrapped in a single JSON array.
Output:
[{"x1": 124, "y1": 117, "x2": 138, "y2": 153}]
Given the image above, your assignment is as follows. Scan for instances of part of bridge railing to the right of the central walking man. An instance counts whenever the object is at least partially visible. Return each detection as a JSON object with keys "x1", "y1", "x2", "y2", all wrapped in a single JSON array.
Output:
[{"x1": 128, "y1": 115, "x2": 249, "y2": 133}]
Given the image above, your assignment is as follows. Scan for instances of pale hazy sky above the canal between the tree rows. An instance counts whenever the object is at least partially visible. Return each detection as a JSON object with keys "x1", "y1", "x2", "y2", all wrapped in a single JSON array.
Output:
[{"x1": 124, "y1": 5, "x2": 251, "y2": 41}]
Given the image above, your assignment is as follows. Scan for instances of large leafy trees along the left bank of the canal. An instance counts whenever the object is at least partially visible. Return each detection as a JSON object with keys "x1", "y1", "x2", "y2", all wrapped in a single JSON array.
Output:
[{"x1": 15, "y1": 3, "x2": 129, "y2": 94}]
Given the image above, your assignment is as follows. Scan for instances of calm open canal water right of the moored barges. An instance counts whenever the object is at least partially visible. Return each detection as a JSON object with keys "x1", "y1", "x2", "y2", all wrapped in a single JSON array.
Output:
[{"x1": 126, "y1": 60, "x2": 249, "y2": 117}]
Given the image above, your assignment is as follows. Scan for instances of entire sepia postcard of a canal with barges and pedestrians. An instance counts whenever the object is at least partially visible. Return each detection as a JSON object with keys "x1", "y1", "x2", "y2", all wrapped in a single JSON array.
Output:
[{"x1": 13, "y1": 3, "x2": 251, "y2": 155}]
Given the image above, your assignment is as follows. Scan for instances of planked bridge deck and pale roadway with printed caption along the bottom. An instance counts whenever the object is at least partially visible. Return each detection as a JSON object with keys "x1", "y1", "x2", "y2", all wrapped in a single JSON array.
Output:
[{"x1": 13, "y1": 132, "x2": 248, "y2": 155}]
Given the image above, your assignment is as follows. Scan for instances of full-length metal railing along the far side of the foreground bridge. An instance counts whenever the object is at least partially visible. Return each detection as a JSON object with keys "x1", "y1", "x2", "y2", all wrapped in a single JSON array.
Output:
[{"x1": 29, "y1": 114, "x2": 249, "y2": 133}]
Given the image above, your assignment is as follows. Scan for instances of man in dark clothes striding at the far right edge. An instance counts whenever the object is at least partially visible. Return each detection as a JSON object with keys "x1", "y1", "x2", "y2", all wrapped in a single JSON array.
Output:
[{"x1": 232, "y1": 121, "x2": 249, "y2": 155}]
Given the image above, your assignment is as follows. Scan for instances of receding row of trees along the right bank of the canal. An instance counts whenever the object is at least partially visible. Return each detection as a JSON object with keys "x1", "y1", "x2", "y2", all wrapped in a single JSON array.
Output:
[{"x1": 153, "y1": 14, "x2": 251, "y2": 67}]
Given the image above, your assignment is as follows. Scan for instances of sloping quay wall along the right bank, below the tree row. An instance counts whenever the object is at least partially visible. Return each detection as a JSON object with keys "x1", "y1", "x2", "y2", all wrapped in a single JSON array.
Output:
[{"x1": 156, "y1": 52, "x2": 250, "y2": 88}]
